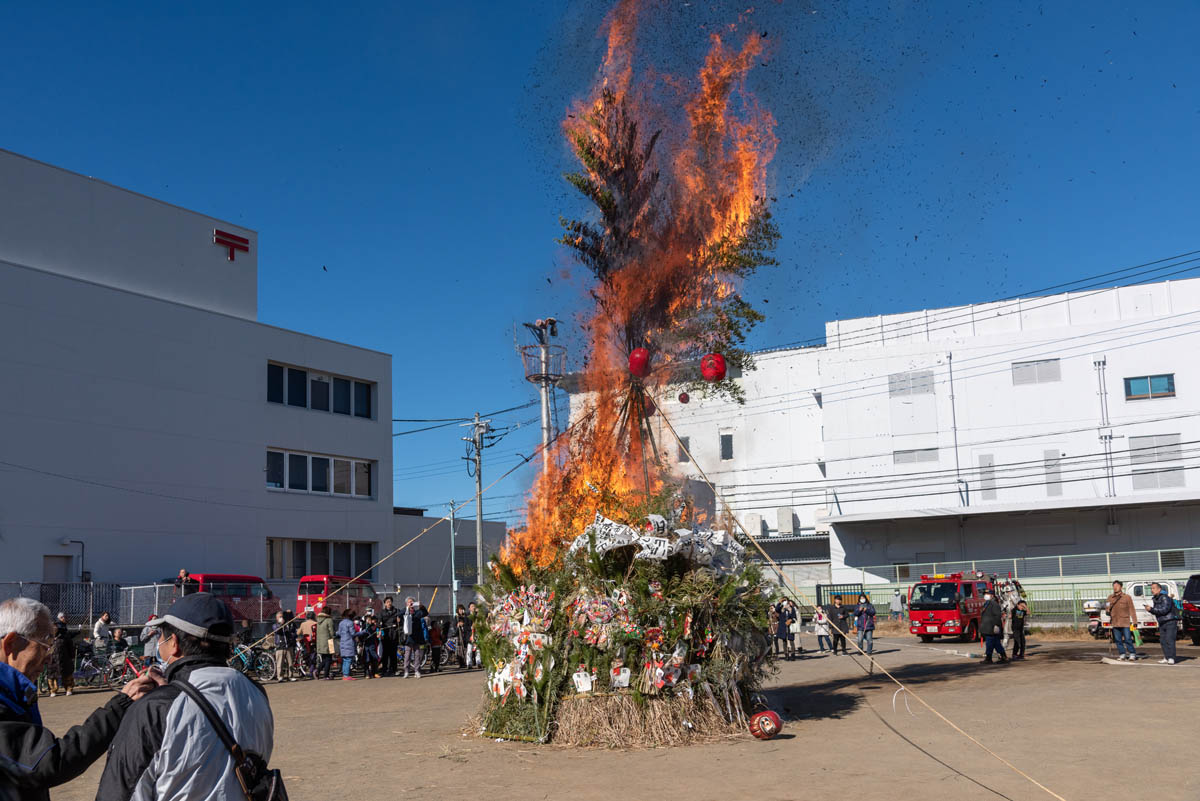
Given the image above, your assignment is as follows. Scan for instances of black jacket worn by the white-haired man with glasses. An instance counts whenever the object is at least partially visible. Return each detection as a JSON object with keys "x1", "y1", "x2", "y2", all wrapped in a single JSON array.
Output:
[{"x1": 0, "y1": 664, "x2": 133, "y2": 801}]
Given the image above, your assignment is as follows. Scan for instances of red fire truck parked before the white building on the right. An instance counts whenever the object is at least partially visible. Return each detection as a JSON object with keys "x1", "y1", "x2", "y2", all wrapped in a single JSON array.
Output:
[{"x1": 908, "y1": 571, "x2": 1022, "y2": 643}]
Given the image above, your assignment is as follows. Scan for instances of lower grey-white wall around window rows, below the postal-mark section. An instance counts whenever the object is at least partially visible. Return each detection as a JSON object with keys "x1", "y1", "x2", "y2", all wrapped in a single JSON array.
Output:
[{"x1": 0, "y1": 261, "x2": 394, "y2": 584}]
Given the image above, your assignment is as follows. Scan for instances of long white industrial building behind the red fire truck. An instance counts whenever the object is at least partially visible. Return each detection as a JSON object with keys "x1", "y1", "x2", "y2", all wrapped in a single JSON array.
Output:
[{"x1": 652, "y1": 273, "x2": 1200, "y2": 582}]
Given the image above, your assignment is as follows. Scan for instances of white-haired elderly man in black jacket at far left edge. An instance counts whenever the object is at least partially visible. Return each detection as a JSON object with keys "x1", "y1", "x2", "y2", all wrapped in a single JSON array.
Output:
[{"x1": 0, "y1": 598, "x2": 157, "y2": 800}]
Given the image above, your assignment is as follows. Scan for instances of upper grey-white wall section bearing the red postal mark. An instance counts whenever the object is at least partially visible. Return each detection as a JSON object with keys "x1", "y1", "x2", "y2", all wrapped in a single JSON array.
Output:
[{"x1": 0, "y1": 150, "x2": 258, "y2": 320}]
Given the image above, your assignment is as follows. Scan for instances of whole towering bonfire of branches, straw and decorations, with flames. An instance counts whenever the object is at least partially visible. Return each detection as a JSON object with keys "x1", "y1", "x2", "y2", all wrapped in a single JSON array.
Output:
[{"x1": 476, "y1": 0, "x2": 776, "y2": 746}]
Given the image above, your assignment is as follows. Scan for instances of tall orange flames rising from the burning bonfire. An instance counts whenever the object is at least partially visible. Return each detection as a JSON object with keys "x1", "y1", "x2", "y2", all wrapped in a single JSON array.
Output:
[{"x1": 502, "y1": 0, "x2": 778, "y2": 571}]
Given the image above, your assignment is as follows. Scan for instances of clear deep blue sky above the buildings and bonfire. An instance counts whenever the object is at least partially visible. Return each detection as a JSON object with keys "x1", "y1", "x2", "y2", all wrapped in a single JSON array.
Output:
[{"x1": 0, "y1": 0, "x2": 1200, "y2": 525}]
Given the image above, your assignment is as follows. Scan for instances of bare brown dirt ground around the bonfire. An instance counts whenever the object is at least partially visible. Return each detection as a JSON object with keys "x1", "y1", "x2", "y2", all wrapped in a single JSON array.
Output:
[{"x1": 42, "y1": 638, "x2": 1200, "y2": 801}]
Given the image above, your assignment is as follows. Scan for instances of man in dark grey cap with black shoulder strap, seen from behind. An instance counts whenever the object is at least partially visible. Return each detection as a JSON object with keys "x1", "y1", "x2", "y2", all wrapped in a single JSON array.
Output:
[{"x1": 96, "y1": 592, "x2": 275, "y2": 801}]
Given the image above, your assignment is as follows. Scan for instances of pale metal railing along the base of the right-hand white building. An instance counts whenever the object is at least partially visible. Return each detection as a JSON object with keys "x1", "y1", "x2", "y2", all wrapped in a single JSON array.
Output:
[{"x1": 853, "y1": 548, "x2": 1200, "y2": 584}]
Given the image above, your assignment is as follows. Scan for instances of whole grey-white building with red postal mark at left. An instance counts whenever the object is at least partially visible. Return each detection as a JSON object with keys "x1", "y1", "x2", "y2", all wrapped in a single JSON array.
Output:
[{"x1": 0, "y1": 151, "x2": 395, "y2": 584}]
